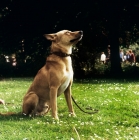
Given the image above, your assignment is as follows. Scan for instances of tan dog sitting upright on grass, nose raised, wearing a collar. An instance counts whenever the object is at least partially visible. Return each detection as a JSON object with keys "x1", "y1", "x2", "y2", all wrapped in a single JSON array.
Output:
[{"x1": 22, "y1": 30, "x2": 83, "y2": 120}]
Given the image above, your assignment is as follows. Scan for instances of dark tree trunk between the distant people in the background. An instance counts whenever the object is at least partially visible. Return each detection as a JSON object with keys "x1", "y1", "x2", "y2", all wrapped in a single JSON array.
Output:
[{"x1": 109, "y1": 5, "x2": 122, "y2": 77}]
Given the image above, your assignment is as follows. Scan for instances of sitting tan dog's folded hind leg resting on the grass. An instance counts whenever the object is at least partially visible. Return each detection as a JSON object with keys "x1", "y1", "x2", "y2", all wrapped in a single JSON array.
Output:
[{"x1": 22, "y1": 92, "x2": 39, "y2": 115}]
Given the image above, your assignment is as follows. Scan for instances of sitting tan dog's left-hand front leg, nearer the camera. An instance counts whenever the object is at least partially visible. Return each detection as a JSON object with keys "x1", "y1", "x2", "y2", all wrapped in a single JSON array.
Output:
[{"x1": 50, "y1": 87, "x2": 59, "y2": 120}]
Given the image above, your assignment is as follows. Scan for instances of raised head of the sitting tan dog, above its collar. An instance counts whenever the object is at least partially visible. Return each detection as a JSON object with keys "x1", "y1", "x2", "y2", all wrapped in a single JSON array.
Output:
[{"x1": 44, "y1": 30, "x2": 83, "y2": 46}]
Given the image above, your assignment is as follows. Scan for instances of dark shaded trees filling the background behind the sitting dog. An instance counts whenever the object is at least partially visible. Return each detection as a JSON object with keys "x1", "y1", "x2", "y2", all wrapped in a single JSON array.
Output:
[{"x1": 0, "y1": 0, "x2": 139, "y2": 77}]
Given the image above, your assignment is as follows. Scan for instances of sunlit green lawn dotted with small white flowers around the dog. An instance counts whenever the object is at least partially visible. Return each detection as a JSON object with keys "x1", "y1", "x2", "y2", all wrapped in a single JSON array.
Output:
[{"x1": 0, "y1": 78, "x2": 139, "y2": 140}]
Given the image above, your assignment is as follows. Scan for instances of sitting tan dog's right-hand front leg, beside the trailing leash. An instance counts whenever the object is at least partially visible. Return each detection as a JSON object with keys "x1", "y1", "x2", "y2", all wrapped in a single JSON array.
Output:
[{"x1": 64, "y1": 83, "x2": 76, "y2": 116}]
